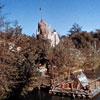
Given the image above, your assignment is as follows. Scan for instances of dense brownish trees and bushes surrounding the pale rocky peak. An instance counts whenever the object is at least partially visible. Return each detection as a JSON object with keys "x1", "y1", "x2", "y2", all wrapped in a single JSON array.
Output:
[{"x1": 0, "y1": 5, "x2": 100, "y2": 99}]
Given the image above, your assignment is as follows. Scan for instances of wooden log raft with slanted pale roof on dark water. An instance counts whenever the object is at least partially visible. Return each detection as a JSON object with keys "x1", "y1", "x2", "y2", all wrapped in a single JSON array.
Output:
[{"x1": 49, "y1": 70, "x2": 100, "y2": 98}]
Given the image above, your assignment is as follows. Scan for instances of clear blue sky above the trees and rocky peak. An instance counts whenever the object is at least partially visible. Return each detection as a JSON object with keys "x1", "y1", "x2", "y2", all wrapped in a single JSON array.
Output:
[{"x1": 0, "y1": 0, "x2": 100, "y2": 35}]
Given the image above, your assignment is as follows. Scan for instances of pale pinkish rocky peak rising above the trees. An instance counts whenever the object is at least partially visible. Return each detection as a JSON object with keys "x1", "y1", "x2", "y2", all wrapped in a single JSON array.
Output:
[{"x1": 36, "y1": 19, "x2": 60, "y2": 47}]
